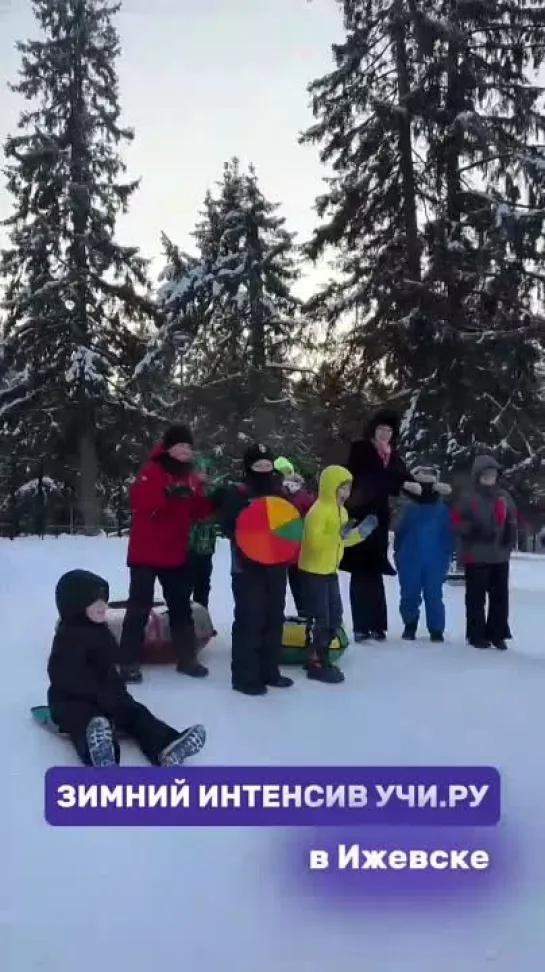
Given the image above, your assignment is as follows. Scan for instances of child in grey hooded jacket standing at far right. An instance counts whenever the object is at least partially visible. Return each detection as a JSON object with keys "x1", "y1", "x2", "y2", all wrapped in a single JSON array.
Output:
[{"x1": 453, "y1": 456, "x2": 517, "y2": 651}]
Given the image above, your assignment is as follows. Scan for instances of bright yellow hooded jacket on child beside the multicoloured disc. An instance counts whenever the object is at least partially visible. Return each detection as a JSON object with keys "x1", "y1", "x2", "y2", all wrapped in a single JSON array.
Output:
[{"x1": 299, "y1": 466, "x2": 361, "y2": 576}]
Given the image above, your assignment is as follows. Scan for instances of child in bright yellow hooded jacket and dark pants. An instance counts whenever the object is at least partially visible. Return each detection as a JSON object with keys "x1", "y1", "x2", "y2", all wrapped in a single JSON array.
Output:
[{"x1": 298, "y1": 466, "x2": 377, "y2": 684}]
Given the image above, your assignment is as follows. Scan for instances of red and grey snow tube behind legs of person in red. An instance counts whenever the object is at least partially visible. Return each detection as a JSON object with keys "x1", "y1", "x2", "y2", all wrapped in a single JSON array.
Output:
[{"x1": 106, "y1": 601, "x2": 215, "y2": 665}]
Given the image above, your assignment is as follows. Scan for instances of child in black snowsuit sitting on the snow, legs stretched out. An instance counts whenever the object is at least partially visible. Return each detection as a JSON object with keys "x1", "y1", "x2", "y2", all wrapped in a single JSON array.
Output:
[{"x1": 47, "y1": 570, "x2": 206, "y2": 766}]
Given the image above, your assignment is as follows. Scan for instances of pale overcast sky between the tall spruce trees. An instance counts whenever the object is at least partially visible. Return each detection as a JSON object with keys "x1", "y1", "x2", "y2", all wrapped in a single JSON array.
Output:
[{"x1": 0, "y1": 0, "x2": 341, "y2": 290}]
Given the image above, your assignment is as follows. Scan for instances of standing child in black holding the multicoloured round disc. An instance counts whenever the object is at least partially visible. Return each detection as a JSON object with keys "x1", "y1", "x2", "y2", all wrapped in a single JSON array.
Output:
[{"x1": 215, "y1": 445, "x2": 293, "y2": 695}]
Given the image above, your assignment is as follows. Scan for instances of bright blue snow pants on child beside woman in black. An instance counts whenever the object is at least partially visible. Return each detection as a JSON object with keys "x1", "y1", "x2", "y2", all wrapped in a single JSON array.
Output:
[{"x1": 396, "y1": 560, "x2": 445, "y2": 634}]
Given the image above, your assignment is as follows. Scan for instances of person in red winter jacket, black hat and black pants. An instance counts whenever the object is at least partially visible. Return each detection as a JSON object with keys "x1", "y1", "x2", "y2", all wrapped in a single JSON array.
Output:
[{"x1": 120, "y1": 425, "x2": 214, "y2": 682}]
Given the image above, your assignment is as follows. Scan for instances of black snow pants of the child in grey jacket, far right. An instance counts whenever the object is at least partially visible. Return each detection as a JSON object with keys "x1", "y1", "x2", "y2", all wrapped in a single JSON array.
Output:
[{"x1": 465, "y1": 563, "x2": 511, "y2": 645}]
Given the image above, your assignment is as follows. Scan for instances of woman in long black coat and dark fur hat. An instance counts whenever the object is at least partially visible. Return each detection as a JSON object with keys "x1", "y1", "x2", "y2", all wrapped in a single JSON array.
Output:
[{"x1": 341, "y1": 409, "x2": 411, "y2": 642}]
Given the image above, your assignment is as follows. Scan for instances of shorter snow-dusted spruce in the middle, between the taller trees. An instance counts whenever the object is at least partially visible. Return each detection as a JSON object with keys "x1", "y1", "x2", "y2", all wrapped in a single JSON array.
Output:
[{"x1": 155, "y1": 159, "x2": 303, "y2": 448}]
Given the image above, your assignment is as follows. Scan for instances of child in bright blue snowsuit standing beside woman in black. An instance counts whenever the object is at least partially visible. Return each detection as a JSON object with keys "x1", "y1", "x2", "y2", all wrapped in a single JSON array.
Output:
[{"x1": 394, "y1": 462, "x2": 455, "y2": 642}]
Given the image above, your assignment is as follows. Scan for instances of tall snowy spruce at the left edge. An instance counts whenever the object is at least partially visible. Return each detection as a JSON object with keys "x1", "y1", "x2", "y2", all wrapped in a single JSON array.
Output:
[{"x1": 1, "y1": 0, "x2": 150, "y2": 531}]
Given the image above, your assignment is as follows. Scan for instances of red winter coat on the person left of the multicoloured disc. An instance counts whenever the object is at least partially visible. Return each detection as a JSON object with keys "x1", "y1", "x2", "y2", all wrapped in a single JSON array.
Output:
[{"x1": 127, "y1": 446, "x2": 215, "y2": 570}]
